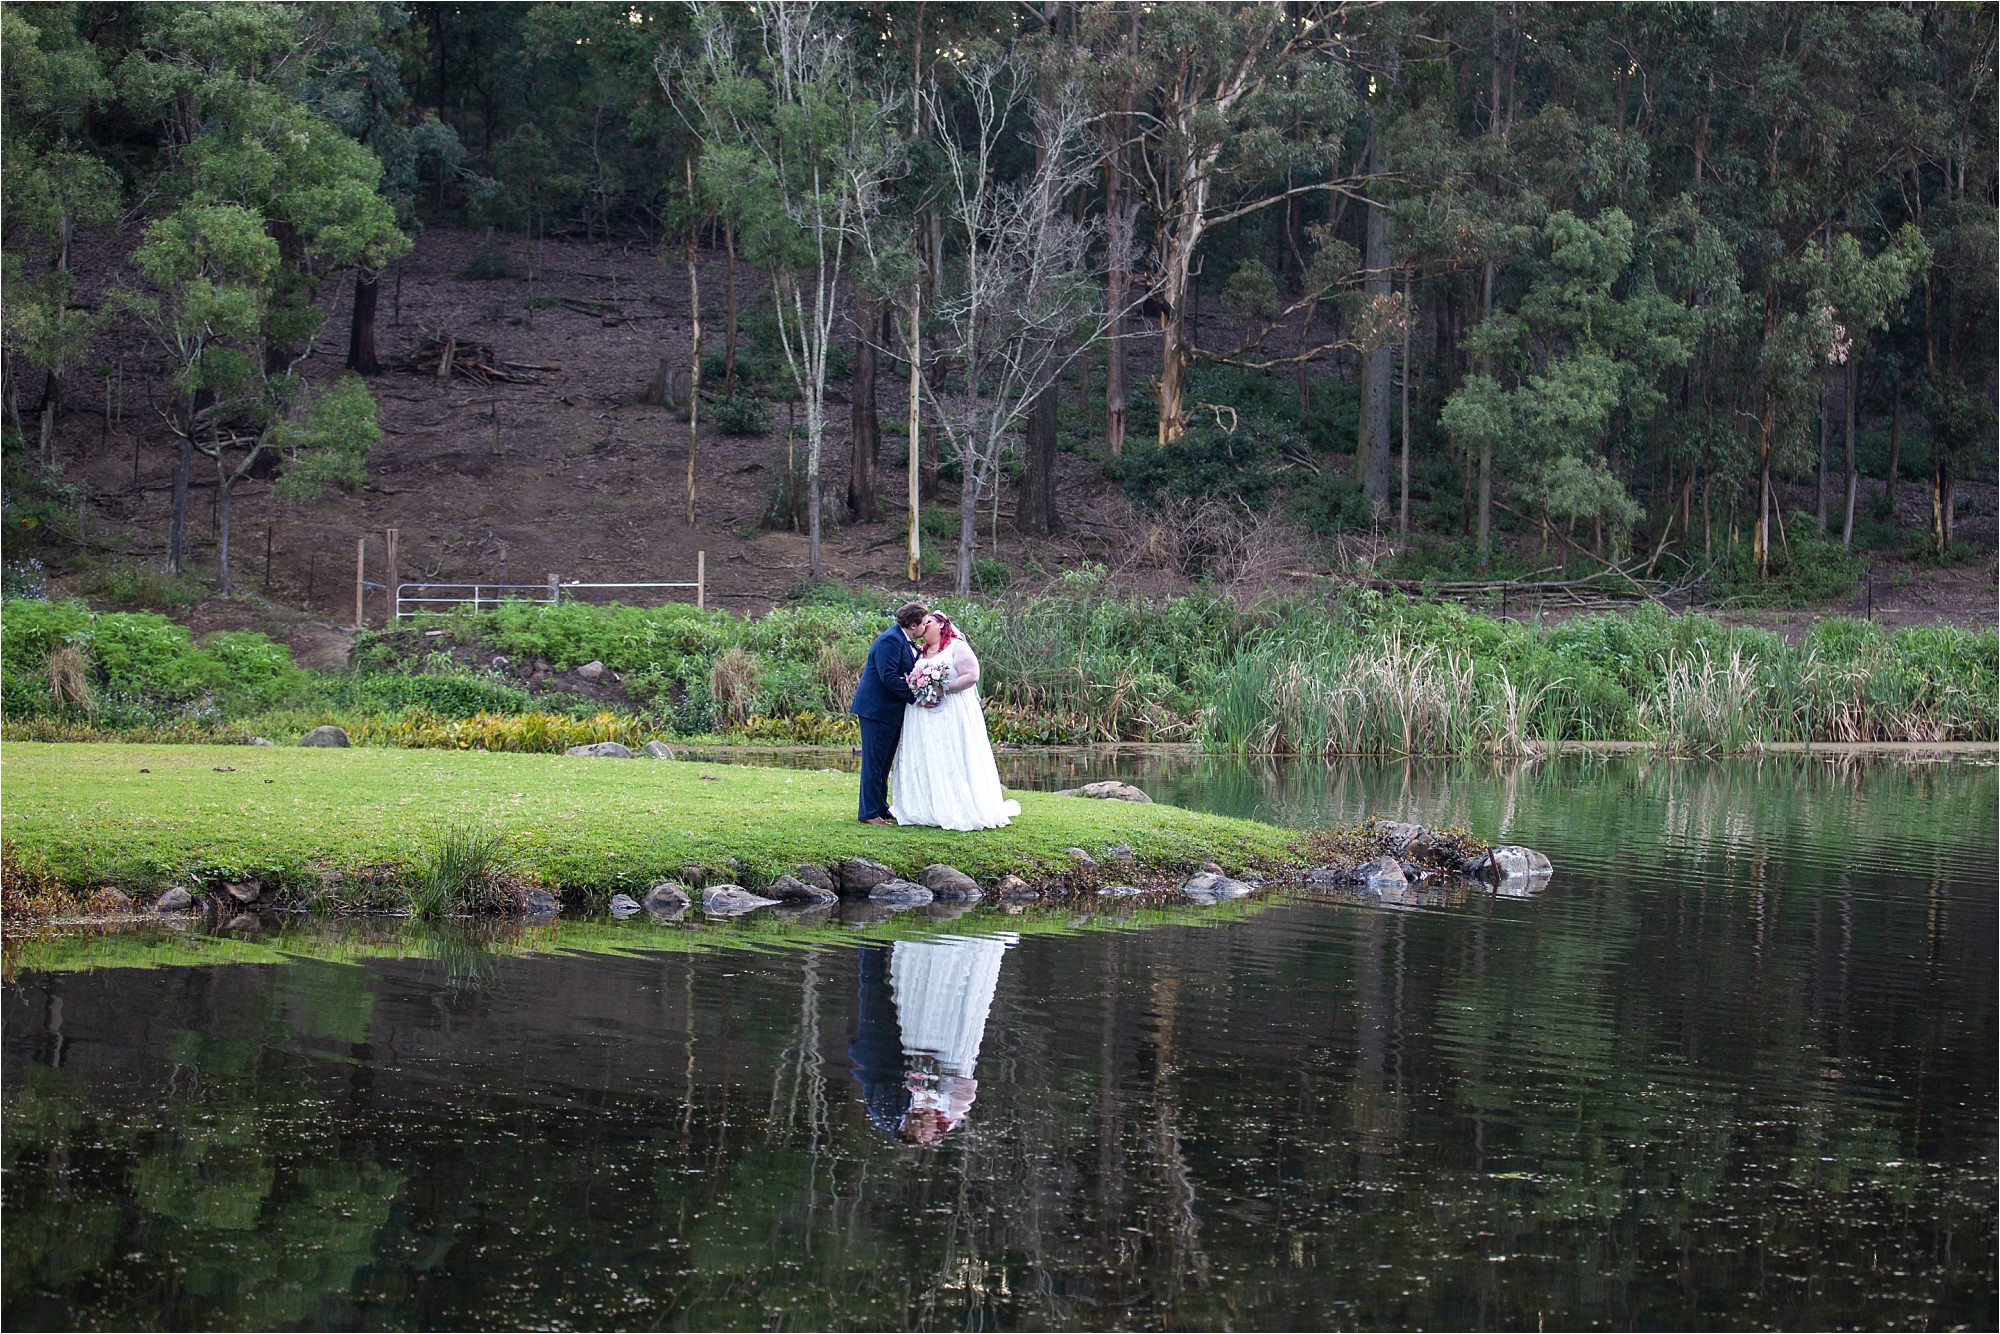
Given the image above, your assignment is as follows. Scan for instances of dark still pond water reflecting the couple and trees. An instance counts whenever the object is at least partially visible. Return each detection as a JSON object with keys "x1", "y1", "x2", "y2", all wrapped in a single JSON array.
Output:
[{"x1": 0, "y1": 756, "x2": 2000, "y2": 1330}]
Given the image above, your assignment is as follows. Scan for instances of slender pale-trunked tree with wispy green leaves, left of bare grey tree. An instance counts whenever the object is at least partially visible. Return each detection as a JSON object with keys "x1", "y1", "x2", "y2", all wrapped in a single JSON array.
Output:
[{"x1": 656, "y1": 2, "x2": 902, "y2": 578}]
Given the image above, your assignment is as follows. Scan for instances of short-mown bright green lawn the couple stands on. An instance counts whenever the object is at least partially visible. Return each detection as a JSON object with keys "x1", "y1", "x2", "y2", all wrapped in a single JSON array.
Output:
[{"x1": 0, "y1": 742, "x2": 1296, "y2": 900}]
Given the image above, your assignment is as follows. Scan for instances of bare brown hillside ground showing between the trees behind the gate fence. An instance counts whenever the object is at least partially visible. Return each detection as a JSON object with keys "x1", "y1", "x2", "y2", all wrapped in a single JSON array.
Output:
[{"x1": 10, "y1": 226, "x2": 1994, "y2": 666}]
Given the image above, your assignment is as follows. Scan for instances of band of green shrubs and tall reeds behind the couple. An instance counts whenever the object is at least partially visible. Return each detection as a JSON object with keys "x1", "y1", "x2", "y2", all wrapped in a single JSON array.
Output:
[{"x1": 0, "y1": 586, "x2": 2000, "y2": 754}]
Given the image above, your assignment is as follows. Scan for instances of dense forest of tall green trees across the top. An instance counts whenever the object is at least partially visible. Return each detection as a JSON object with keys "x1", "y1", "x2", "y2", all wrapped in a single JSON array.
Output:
[{"x1": 0, "y1": 0, "x2": 2000, "y2": 592}]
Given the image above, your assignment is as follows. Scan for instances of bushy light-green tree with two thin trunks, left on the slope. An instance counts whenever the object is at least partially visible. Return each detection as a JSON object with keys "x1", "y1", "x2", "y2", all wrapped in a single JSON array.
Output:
[{"x1": 118, "y1": 4, "x2": 410, "y2": 592}]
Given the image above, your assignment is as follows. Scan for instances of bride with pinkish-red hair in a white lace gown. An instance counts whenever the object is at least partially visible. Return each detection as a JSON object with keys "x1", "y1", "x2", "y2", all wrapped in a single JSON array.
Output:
[{"x1": 888, "y1": 612, "x2": 1020, "y2": 830}]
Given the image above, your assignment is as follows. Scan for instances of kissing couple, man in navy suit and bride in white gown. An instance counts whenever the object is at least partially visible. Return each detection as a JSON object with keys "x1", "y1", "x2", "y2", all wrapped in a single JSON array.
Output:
[{"x1": 848, "y1": 602, "x2": 1020, "y2": 830}]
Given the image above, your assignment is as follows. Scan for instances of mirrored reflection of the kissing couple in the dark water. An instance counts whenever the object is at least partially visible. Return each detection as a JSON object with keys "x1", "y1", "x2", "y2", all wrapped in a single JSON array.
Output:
[{"x1": 848, "y1": 932, "x2": 1020, "y2": 1144}]
